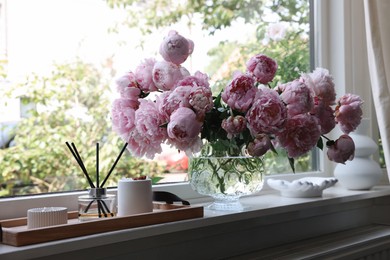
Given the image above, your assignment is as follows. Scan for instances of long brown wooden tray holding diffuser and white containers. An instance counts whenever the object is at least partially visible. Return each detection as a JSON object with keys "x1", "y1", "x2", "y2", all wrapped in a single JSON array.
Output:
[{"x1": 0, "y1": 203, "x2": 203, "y2": 246}]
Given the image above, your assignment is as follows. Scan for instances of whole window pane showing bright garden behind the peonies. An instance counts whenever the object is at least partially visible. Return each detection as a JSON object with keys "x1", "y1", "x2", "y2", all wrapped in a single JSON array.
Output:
[{"x1": 0, "y1": 0, "x2": 310, "y2": 196}]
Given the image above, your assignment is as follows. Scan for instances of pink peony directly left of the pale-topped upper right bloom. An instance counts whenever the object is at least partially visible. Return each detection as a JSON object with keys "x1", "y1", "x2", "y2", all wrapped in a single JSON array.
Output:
[{"x1": 281, "y1": 80, "x2": 313, "y2": 116}]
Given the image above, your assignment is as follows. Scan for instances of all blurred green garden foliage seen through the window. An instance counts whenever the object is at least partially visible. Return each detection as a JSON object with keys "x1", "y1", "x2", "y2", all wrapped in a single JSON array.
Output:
[{"x1": 0, "y1": 0, "x2": 310, "y2": 196}]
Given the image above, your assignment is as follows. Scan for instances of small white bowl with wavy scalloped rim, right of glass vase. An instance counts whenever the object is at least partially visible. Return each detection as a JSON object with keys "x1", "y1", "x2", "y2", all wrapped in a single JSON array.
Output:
[{"x1": 267, "y1": 177, "x2": 337, "y2": 198}]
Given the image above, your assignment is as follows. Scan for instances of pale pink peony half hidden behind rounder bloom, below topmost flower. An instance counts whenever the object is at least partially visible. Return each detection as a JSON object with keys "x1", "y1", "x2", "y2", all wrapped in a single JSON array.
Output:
[{"x1": 135, "y1": 58, "x2": 158, "y2": 93}]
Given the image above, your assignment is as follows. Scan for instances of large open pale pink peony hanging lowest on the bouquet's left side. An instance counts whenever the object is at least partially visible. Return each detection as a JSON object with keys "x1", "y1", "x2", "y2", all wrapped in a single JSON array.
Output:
[{"x1": 127, "y1": 99, "x2": 167, "y2": 159}]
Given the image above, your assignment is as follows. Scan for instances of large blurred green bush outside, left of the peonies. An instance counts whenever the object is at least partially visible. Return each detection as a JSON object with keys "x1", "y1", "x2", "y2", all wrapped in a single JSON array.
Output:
[{"x1": 0, "y1": 60, "x2": 163, "y2": 196}]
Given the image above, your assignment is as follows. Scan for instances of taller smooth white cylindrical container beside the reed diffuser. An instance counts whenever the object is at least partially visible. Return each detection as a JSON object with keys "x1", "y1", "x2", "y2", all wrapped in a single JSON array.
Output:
[{"x1": 118, "y1": 178, "x2": 153, "y2": 217}]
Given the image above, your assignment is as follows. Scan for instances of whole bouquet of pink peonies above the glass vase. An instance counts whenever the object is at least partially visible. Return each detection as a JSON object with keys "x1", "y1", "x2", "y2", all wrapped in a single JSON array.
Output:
[{"x1": 111, "y1": 31, "x2": 363, "y2": 171}]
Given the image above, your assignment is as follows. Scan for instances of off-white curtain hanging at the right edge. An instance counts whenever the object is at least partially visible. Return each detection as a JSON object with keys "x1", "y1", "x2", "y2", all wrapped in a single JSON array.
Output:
[{"x1": 364, "y1": 0, "x2": 390, "y2": 179}]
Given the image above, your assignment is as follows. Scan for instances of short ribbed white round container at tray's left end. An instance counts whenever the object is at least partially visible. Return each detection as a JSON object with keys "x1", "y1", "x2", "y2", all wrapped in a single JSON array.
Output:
[{"x1": 27, "y1": 207, "x2": 68, "y2": 229}]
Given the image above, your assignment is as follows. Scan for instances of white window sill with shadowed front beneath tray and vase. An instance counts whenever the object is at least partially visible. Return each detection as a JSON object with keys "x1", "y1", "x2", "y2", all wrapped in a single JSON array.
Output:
[{"x1": 0, "y1": 185, "x2": 390, "y2": 259}]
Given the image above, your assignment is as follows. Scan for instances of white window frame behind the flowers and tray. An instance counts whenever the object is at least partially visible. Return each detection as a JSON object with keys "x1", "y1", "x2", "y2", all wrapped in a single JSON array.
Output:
[{"x1": 0, "y1": 0, "x2": 375, "y2": 220}]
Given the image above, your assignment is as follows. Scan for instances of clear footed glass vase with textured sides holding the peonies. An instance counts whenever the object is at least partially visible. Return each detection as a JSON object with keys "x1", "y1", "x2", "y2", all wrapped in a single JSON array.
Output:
[{"x1": 188, "y1": 148, "x2": 264, "y2": 211}]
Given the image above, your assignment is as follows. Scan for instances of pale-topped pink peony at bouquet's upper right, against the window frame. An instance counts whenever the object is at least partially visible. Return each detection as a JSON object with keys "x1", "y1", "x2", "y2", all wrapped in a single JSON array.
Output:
[{"x1": 300, "y1": 68, "x2": 336, "y2": 106}]
